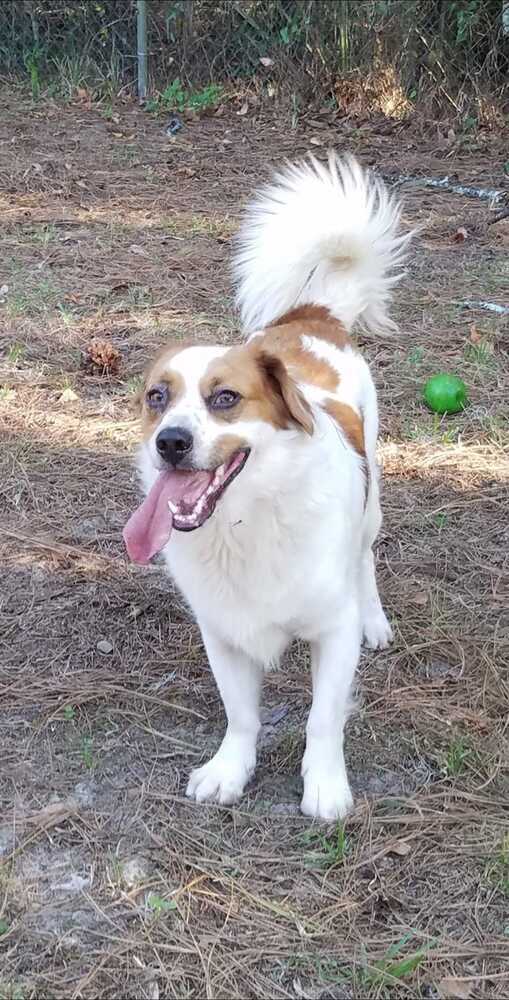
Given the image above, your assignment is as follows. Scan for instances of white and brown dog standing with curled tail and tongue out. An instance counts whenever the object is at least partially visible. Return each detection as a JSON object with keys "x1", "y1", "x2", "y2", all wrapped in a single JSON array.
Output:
[{"x1": 124, "y1": 154, "x2": 410, "y2": 820}]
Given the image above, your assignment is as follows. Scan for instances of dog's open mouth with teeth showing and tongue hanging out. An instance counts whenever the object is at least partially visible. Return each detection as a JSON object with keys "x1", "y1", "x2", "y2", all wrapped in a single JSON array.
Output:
[{"x1": 123, "y1": 448, "x2": 249, "y2": 563}]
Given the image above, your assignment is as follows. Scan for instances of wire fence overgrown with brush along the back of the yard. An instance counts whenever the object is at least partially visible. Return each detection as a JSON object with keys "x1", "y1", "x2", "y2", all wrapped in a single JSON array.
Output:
[{"x1": 0, "y1": 0, "x2": 509, "y2": 114}]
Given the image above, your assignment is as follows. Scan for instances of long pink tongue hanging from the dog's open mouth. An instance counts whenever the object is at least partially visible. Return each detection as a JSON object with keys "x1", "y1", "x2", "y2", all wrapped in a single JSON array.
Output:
[{"x1": 123, "y1": 472, "x2": 210, "y2": 563}]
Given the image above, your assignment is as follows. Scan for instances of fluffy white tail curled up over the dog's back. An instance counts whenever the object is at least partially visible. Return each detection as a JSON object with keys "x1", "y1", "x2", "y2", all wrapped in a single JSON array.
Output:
[{"x1": 234, "y1": 153, "x2": 411, "y2": 333}]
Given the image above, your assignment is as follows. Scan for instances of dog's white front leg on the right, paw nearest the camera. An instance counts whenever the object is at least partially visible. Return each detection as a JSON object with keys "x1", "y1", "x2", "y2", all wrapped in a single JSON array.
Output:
[{"x1": 301, "y1": 601, "x2": 361, "y2": 820}]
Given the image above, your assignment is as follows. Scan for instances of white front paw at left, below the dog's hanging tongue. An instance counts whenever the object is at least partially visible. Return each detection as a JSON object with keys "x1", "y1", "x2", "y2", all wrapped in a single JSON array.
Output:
[{"x1": 186, "y1": 750, "x2": 255, "y2": 805}]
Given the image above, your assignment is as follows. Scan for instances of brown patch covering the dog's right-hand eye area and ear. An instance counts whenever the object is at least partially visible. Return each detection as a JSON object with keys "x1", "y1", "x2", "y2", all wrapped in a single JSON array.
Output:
[{"x1": 200, "y1": 339, "x2": 313, "y2": 434}]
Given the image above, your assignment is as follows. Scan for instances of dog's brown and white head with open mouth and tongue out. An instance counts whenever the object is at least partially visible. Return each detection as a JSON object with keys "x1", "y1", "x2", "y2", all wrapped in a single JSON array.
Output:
[{"x1": 124, "y1": 337, "x2": 313, "y2": 562}]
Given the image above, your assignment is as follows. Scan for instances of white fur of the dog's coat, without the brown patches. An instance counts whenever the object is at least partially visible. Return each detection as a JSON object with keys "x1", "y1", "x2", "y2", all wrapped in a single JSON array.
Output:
[{"x1": 136, "y1": 152, "x2": 403, "y2": 820}]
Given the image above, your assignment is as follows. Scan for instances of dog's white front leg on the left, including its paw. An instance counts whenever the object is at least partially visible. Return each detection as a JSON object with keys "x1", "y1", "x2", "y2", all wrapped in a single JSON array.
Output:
[{"x1": 186, "y1": 627, "x2": 262, "y2": 805}]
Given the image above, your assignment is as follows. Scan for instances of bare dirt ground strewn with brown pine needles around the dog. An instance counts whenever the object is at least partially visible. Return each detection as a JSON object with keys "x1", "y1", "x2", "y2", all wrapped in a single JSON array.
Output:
[{"x1": 0, "y1": 91, "x2": 509, "y2": 1000}]
